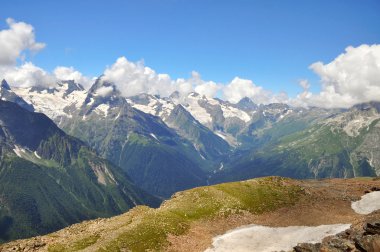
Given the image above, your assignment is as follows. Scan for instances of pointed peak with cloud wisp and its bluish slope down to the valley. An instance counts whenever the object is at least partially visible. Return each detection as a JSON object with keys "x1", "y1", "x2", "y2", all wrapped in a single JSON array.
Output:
[{"x1": 60, "y1": 79, "x2": 206, "y2": 198}]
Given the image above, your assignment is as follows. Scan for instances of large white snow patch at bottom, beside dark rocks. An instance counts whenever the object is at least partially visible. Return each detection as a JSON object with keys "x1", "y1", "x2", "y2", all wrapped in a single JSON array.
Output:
[{"x1": 205, "y1": 224, "x2": 350, "y2": 252}]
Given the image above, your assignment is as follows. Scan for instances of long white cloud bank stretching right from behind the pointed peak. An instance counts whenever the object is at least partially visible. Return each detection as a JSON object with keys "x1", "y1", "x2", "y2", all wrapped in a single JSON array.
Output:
[{"x1": 102, "y1": 57, "x2": 287, "y2": 103}]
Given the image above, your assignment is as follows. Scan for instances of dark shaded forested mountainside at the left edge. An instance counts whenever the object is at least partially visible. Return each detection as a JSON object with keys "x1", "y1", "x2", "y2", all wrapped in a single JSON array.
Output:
[{"x1": 0, "y1": 101, "x2": 159, "y2": 241}]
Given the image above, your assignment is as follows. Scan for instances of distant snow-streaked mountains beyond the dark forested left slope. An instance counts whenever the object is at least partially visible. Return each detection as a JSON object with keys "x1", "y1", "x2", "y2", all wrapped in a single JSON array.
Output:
[{"x1": 4, "y1": 77, "x2": 380, "y2": 193}]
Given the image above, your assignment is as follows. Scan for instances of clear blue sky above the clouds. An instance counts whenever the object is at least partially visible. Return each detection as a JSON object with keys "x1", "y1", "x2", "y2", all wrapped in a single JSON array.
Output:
[{"x1": 0, "y1": 0, "x2": 380, "y2": 96}]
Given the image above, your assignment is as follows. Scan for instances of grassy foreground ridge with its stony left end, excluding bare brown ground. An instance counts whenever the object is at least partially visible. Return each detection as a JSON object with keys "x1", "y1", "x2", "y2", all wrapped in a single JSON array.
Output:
[{"x1": 0, "y1": 177, "x2": 304, "y2": 251}]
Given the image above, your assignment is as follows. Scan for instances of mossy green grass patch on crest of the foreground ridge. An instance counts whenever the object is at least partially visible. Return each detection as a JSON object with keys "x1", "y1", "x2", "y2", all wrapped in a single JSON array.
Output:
[{"x1": 100, "y1": 177, "x2": 303, "y2": 251}]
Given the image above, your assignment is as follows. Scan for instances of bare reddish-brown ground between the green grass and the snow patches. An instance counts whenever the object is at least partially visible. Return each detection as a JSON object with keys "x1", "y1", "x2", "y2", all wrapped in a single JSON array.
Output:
[{"x1": 169, "y1": 179, "x2": 380, "y2": 252}]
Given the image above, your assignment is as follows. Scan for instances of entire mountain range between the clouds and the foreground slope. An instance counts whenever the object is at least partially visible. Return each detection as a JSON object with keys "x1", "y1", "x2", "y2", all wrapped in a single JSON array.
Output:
[{"x1": 0, "y1": 77, "x2": 380, "y2": 240}]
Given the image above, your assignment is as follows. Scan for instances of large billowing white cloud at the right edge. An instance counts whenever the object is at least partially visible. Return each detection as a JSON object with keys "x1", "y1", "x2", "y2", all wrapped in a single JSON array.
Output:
[{"x1": 295, "y1": 44, "x2": 380, "y2": 108}]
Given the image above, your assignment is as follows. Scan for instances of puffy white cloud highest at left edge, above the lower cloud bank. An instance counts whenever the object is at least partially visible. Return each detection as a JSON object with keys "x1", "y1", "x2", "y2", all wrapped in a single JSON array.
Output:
[{"x1": 0, "y1": 18, "x2": 45, "y2": 66}]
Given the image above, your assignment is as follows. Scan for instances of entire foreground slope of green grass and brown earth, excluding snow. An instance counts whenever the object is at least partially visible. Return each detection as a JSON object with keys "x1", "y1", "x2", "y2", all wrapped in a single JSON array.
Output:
[{"x1": 0, "y1": 177, "x2": 380, "y2": 251}]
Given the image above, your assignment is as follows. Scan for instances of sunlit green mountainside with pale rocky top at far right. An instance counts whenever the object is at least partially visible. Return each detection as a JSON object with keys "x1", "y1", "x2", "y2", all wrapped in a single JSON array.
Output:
[{"x1": 213, "y1": 102, "x2": 380, "y2": 182}]
